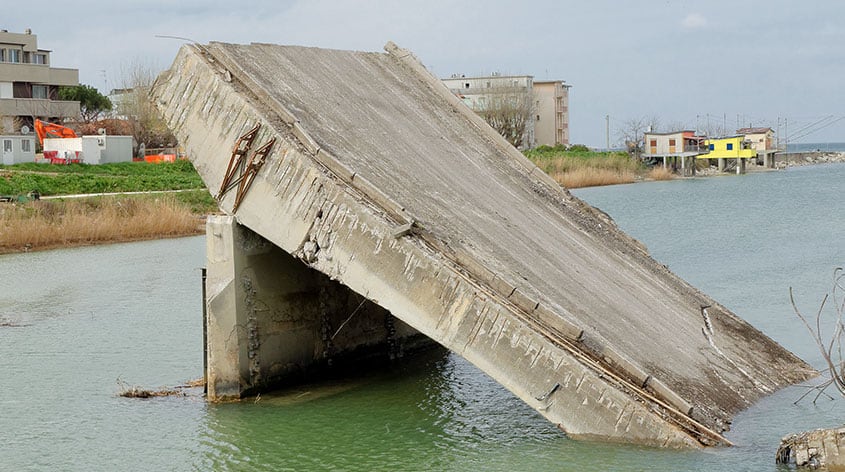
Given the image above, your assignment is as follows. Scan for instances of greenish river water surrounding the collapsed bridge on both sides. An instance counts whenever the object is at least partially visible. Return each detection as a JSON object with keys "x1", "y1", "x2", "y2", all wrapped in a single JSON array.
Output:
[{"x1": 0, "y1": 165, "x2": 845, "y2": 471}]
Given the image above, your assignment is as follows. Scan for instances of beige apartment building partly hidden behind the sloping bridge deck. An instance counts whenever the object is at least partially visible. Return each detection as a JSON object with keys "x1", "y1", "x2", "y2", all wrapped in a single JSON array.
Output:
[{"x1": 442, "y1": 73, "x2": 570, "y2": 149}]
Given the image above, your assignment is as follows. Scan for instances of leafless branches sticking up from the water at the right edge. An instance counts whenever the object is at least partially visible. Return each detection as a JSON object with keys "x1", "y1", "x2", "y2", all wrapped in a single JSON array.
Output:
[{"x1": 789, "y1": 267, "x2": 845, "y2": 403}]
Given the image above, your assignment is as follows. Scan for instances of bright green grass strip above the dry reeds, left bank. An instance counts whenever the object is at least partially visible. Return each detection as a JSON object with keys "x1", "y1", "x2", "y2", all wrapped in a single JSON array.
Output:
[{"x1": 0, "y1": 160, "x2": 205, "y2": 196}]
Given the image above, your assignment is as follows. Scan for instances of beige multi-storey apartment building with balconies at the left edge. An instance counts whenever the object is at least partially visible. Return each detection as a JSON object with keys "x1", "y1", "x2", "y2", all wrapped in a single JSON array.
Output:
[{"x1": 0, "y1": 30, "x2": 79, "y2": 134}]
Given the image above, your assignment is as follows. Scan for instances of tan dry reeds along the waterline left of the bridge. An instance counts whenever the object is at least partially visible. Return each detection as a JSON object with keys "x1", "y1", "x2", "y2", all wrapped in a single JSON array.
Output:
[{"x1": 0, "y1": 198, "x2": 202, "y2": 253}]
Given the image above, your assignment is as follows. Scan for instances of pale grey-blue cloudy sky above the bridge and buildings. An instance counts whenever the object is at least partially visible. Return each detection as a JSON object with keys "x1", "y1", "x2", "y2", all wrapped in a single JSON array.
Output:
[{"x1": 6, "y1": 0, "x2": 845, "y2": 147}]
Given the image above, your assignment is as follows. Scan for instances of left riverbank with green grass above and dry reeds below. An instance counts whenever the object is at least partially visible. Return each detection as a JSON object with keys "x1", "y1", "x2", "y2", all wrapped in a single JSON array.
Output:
[{"x1": 0, "y1": 161, "x2": 217, "y2": 254}]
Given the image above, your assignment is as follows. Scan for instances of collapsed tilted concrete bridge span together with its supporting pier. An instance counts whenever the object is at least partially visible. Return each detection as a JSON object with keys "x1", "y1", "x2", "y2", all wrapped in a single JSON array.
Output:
[{"x1": 153, "y1": 39, "x2": 814, "y2": 447}]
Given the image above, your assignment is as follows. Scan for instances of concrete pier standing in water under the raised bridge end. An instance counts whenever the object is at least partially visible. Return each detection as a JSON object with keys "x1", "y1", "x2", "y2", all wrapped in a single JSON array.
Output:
[{"x1": 206, "y1": 216, "x2": 431, "y2": 401}]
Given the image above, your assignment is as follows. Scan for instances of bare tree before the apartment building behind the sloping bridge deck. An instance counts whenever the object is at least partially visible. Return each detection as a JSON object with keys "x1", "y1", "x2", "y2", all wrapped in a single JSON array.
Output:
[{"x1": 473, "y1": 85, "x2": 534, "y2": 149}]
